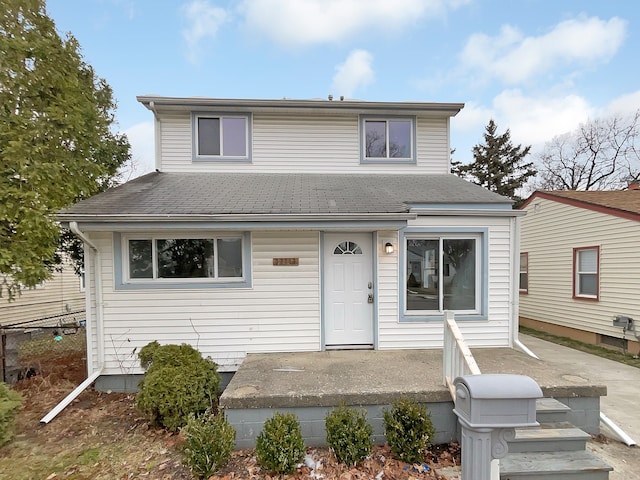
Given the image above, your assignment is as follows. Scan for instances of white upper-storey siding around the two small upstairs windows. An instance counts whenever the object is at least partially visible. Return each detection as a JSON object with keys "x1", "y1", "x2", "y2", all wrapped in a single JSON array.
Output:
[{"x1": 159, "y1": 112, "x2": 450, "y2": 174}]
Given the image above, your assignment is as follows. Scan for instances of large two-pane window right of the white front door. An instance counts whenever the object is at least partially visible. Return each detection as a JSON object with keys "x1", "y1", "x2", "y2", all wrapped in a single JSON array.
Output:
[{"x1": 405, "y1": 237, "x2": 480, "y2": 314}]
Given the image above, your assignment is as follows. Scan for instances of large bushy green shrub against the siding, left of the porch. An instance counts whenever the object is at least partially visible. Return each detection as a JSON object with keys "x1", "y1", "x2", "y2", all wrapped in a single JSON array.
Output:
[{"x1": 136, "y1": 342, "x2": 220, "y2": 432}]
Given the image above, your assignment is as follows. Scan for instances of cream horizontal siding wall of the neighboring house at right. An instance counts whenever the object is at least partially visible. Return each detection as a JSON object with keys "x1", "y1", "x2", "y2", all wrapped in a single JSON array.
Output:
[{"x1": 520, "y1": 198, "x2": 640, "y2": 337}]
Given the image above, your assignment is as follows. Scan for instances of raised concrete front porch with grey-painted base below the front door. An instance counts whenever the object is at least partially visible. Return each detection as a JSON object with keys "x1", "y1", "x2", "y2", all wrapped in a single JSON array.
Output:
[{"x1": 220, "y1": 348, "x2": 606, "y2": 448}]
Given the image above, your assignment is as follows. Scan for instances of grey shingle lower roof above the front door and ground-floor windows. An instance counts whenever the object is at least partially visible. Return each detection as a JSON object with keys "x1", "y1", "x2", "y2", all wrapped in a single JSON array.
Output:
[{"x1": 60, "y1": 172, "x2": 511, "y2": 221}]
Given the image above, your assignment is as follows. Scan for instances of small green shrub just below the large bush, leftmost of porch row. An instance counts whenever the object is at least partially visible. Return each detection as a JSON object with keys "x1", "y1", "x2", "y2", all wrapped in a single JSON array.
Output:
[{"x1": 181, "y1": 410, "x2": 236, "y2": 478}]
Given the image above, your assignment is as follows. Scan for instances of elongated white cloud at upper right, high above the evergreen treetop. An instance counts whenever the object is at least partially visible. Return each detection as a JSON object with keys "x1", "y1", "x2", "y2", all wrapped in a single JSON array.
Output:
[{"x1": 460, "y1": 16, "x2": 627, "y2": 84}]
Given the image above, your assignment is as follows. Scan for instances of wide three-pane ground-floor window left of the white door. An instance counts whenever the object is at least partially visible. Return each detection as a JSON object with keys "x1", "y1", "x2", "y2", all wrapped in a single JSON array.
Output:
[{"x1": 126, "y1": 236, "x2": 243, "y2": 281}]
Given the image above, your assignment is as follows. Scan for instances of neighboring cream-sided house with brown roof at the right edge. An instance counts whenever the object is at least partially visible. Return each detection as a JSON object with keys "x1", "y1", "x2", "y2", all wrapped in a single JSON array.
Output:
[{"x1": 520, "y1": 187, "x2": 640, "y2": 354}]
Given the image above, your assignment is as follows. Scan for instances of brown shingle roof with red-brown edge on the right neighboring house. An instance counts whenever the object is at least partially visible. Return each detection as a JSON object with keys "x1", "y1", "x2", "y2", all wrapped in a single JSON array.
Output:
[{"x1": 523, "y1": 190, "x2": 640, "y2": 220}]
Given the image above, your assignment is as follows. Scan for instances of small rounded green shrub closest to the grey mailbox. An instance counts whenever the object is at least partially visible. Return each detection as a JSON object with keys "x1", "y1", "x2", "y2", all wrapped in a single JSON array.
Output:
[{"x1": 384, "y1": 400, "x2": 435, "y2": 463}]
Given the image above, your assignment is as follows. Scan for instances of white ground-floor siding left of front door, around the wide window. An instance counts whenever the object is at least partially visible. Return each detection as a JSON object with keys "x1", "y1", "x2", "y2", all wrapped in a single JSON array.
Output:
[{"x1": 86, "y1": 232, "x2": 321, "y2": 374}]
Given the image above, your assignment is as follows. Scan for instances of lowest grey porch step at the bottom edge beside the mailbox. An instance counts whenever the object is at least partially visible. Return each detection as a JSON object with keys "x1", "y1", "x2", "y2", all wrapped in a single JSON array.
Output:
[{"x1": 500, "y1": 451, "x2": 613, "y2": 480}]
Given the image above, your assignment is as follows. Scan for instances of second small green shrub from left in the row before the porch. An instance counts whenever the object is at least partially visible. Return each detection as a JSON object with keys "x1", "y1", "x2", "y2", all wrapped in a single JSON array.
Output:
[{"x1": 256, "y1": 413, "x2": 305, "y2": 473}]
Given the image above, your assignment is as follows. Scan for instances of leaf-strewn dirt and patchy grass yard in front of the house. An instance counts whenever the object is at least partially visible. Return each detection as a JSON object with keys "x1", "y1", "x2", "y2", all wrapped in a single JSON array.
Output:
[{"x1": 0, "y1": 348, "x2": 460, "y2": 480}]
